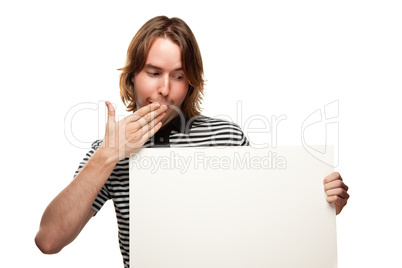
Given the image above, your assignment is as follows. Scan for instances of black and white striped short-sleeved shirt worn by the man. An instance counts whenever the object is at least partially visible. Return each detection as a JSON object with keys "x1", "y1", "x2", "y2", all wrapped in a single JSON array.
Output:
[{"x1": 75, "y1": 116, "x2": 249, "y2": 268}]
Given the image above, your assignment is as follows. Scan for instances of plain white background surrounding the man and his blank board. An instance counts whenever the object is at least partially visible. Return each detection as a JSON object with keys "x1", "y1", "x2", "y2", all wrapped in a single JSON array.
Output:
[{"x1": 0, "y1": 0, "x2": 402, "y2": 267}]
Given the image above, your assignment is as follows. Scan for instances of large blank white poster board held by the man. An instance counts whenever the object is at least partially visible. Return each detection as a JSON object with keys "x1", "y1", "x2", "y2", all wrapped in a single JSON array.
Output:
[{"x1": 130, "y1": 146, "x2": 337, "y2": 268}]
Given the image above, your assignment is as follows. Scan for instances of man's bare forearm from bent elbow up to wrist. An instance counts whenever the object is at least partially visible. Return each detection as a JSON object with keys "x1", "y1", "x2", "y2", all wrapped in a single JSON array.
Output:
[{"x1": 35, "y1": 148, "x2": 116, "y2": 253}]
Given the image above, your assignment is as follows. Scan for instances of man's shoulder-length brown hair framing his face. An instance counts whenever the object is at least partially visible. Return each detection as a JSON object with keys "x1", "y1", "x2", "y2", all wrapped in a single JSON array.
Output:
[{"x1": 119, "y1": 16, "x2": 204, "y2": 118}]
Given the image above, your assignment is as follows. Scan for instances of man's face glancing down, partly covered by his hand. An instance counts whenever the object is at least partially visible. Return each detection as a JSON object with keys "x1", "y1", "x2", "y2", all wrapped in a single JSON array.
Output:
[{"x1": 131, "y1": 38, "x2": 189, "y2": 125}]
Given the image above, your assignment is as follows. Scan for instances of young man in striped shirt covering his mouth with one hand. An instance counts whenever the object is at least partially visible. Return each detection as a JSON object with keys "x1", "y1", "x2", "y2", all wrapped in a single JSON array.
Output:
[{"x1": 35, "y1": 16, "x2": 349, "y2": 267}]
